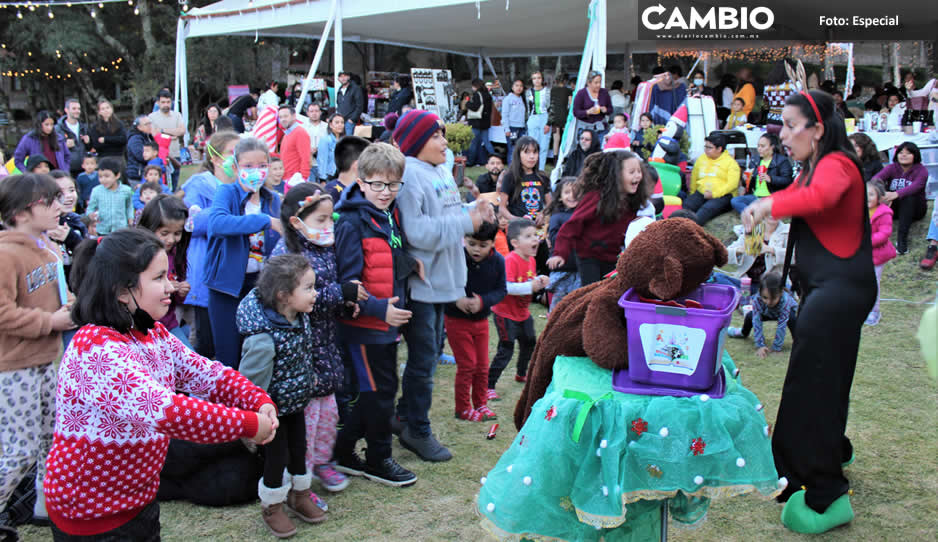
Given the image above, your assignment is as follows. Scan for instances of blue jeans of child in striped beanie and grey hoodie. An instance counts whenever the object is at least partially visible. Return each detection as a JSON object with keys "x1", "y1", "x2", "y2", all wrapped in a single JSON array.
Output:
[{"x1": 397, "y1": 300, "x2": 445, "y2": 438}]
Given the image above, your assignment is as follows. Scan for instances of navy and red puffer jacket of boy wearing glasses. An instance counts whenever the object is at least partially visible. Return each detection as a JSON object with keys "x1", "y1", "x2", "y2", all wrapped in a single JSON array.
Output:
[{"x1": 335, "y1": 184, "x2": 417, "y2": 344}]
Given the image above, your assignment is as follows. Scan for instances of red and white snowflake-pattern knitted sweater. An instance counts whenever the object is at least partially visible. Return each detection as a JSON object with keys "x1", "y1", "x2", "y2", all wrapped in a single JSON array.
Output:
[{"x1": 43, "y1": 323, "x2": 273, "y2": 535}]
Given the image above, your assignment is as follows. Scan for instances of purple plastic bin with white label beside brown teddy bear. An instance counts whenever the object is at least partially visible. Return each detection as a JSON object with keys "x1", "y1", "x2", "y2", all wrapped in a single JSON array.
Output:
[{"x1": 619, "y1": 284, "x2": 739, "y2": 391}]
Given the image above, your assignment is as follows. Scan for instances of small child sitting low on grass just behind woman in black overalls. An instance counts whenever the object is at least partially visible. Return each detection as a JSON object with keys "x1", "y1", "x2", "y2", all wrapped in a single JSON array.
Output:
[{"x1": 726, "y1": 271, "x2": 798, "y2": 359}]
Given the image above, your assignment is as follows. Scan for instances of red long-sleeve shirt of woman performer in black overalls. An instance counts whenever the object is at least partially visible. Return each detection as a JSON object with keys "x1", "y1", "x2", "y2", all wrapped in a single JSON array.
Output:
[{"x1": 769, "y1": 152, "x2": 868, "y2": 258}]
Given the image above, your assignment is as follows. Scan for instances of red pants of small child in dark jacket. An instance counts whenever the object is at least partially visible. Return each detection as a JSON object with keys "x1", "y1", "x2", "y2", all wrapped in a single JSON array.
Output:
[{"x1": 443, "y1": 315, "x2": 489, "y2": 413}]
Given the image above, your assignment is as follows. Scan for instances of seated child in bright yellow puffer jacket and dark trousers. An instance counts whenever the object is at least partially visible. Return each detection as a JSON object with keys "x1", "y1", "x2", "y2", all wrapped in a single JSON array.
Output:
[{"x1": 684, "y1": 132, "x2": 740, "y2": 226}]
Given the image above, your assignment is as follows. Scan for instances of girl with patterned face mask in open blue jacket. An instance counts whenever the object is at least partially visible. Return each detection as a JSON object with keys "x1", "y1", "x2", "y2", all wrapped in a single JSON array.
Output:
[{"x1": 200, "y1": 137, "x2": 283, "y2": 368}]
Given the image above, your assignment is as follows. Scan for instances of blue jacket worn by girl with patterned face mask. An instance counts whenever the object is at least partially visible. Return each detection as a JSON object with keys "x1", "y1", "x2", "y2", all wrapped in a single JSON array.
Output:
[{"x1": 204, "y1": 183, "x2": 280, "y2": 297}]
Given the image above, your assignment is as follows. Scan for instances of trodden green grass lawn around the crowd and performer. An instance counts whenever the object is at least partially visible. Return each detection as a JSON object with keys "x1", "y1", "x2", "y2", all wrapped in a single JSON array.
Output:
[{"x1": 21, "y1": 169, "x2": 938, "y2": 542}]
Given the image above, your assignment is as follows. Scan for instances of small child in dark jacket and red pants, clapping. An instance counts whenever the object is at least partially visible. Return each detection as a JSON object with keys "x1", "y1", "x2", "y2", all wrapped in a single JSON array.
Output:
[{"x1": 443, "y1": 222, "x2": 507, "y2": 422}]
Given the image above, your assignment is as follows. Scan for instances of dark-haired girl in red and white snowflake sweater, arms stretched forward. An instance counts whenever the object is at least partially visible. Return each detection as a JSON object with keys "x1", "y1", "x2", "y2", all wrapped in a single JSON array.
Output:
[{"x1": 44, "y1": 228, "x2": 278, "y2": 542}]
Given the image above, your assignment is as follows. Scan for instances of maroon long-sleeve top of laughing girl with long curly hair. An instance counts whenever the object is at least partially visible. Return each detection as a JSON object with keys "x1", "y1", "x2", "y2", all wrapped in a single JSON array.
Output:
[{"x1": 554, "y1": 190, "x2": 635, "y2": 262}]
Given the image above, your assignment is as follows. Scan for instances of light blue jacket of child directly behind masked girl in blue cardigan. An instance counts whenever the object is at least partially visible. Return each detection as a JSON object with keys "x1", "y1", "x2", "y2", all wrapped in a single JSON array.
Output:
[{"x1": 182, "y1": 171, "x2": 221, "y2": 308}]
